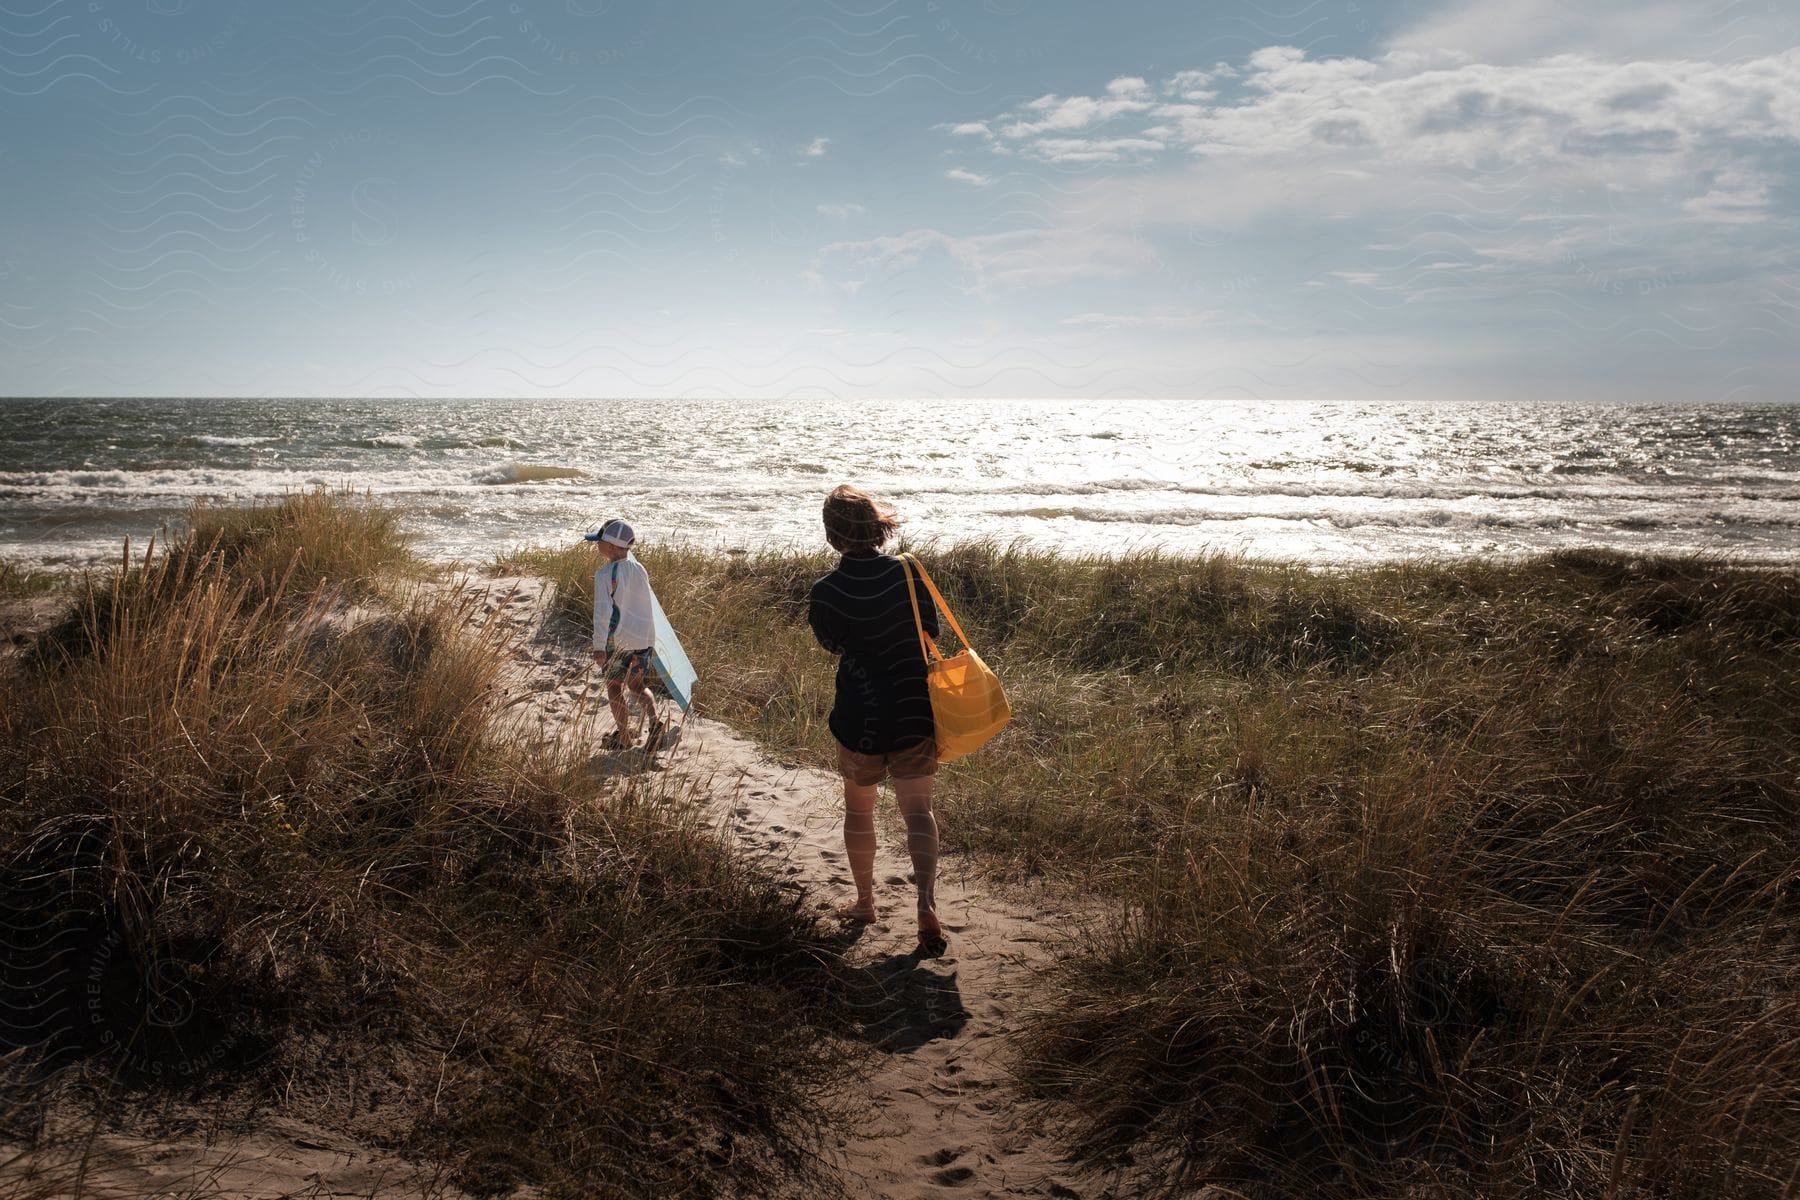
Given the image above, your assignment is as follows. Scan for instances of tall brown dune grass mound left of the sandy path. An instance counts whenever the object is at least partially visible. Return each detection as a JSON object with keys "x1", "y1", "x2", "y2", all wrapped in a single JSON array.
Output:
[{"x1": 0, "y1": 495, "x2": 853, "y2": 1196}]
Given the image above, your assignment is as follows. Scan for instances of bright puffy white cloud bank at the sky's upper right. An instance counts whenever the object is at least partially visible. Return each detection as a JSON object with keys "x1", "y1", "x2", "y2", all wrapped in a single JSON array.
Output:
[{"x1": 957, "y1": 47, "x2": 1800, "y2": 219}]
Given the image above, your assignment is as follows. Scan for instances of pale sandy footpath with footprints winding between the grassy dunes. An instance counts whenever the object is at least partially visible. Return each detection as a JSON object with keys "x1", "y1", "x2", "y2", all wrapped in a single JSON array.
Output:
[{"x1": 472, "y1": 578, "x2": 1103, "y2": 1200}]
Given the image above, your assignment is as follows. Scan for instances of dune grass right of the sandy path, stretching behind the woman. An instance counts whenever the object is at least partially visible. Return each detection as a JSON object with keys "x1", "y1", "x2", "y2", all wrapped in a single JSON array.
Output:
[{"x1": 515, "y1": 545, "x2": 1800, "y2": 1198}]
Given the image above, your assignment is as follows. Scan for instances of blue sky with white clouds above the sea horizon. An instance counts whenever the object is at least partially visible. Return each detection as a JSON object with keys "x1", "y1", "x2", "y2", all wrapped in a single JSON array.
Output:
[{"x1": 0, "y1": 0, "x2": 1800, "y2": 403}]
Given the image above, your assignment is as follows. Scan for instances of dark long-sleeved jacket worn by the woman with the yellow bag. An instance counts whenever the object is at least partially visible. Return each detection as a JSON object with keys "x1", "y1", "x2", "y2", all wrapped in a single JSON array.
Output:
[{"x1": 806, "y1": 552, "x2": 938, "y2": 754}]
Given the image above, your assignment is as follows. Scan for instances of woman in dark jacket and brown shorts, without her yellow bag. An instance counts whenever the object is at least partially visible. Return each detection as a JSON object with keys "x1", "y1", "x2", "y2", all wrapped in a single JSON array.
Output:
[{"x1": 808, "y1": 484, "x2": 947, "y2": 955}]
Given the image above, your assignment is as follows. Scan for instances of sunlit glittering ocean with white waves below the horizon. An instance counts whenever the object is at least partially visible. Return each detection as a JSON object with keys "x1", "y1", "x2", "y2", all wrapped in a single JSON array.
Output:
[{"x1": 0, "y1": 399, "x2": 1800, "y2": 567}]
